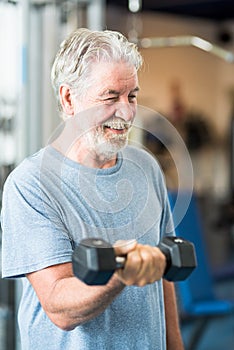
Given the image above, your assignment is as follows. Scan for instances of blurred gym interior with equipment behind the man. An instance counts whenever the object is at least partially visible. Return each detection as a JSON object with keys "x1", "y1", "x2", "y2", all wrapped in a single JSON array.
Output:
[{"x1": 0, "y1": 0, "x2": 234, "y2": 350}]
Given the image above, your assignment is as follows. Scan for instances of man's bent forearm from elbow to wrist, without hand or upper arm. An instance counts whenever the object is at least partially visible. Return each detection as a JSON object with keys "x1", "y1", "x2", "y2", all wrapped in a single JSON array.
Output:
[{"x1": 45, "y1": 277, "x2": 124, "y2": 330}]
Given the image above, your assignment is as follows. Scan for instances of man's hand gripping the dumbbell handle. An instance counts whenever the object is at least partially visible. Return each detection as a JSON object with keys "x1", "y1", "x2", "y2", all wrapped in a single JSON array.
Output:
[{"x1": 114, "y1": 240, "x2": 166, "y2": 287}]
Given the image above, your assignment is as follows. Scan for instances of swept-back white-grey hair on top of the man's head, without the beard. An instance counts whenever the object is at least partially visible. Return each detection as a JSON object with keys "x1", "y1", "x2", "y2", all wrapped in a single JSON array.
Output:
[{"x1": 51, "y1": 28, "x2": 143, "y2": 111}]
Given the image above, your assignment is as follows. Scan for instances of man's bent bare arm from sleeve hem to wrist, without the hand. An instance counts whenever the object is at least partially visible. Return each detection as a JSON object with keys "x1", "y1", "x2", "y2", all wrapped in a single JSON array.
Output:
[{"x1": 27, "y1": 263, "x2": 124, "y2": 331}]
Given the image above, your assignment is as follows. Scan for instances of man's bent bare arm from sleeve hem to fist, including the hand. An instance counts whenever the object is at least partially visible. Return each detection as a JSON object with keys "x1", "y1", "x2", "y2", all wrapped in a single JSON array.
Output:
[{"x1": 27, "y1": 241, "x2": 166, "y2": 330}]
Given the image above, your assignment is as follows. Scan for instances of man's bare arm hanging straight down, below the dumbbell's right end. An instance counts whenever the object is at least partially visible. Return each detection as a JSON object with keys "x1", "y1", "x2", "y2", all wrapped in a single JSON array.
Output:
[{"x1": 163, "y1": 280, "x2": 184, "y2": 350}]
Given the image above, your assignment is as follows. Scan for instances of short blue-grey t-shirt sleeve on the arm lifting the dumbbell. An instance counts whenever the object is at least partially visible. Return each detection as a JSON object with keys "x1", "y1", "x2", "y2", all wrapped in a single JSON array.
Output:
[{"x1": 1, "y1": 164, "x2": 72, "y2": 278}]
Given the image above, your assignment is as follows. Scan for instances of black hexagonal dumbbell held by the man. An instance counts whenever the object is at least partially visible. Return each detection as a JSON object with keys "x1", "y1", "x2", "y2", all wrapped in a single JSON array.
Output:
[{"x1": 72, "y1": 236, "x2": 197, "y2": 285}]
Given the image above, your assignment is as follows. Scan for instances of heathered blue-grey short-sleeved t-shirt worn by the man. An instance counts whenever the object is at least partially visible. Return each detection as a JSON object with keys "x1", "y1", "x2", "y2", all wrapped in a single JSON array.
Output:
[{"x1": 1, "y1": 146, "x2": 172, "y2": 350}]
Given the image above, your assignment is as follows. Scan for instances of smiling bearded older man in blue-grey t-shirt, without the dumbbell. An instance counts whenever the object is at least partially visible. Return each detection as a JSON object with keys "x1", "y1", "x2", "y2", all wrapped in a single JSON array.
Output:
[{"x1": 2, "y1": 29, "x2": 183, "y2": 350}]
